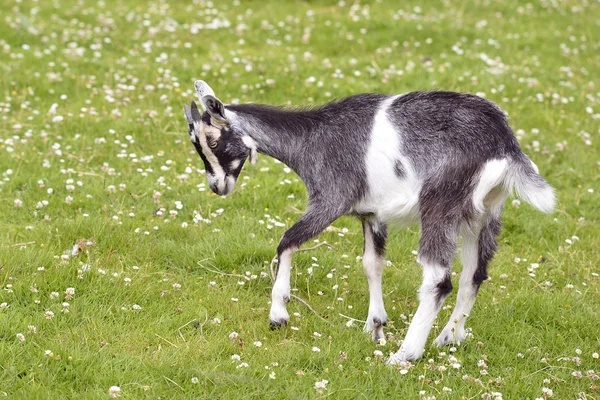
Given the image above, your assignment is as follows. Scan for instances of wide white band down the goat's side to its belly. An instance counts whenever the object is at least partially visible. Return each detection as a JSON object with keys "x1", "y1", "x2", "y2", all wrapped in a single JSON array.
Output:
[{"x1": 353, "y1": 96, "x2": 421, "y2": 225}]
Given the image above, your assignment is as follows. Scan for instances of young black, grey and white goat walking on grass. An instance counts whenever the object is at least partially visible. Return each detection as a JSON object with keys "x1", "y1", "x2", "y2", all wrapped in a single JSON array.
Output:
[{"x1": 184, "y1": 81, "x2": 554, "y2": 363}]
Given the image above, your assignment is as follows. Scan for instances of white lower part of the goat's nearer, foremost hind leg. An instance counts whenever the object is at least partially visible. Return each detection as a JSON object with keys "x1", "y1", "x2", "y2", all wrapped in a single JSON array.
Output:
[{"x1": 388, "y1": 262, "x2": 448, "y2": 364}]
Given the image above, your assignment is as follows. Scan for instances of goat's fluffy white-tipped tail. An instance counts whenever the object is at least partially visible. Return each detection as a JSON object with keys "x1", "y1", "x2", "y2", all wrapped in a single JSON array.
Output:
[{"x1": 504, "y1": 154, "x2": 556, "y2": 213}]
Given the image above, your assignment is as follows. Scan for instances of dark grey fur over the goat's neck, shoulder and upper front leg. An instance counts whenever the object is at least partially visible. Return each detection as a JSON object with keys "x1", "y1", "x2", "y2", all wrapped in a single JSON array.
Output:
[{"x1": 226, "y1": 94, "x2": 388, "y2": 255}]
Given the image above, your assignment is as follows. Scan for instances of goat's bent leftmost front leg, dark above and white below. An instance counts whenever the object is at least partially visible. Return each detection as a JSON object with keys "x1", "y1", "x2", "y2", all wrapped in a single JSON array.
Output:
[{"x1": 269, "y1": 204, "x2": 340, "y2": 328}]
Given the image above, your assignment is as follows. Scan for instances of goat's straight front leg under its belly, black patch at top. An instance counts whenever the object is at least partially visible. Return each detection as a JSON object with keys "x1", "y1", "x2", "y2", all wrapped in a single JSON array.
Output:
[{"x1": 363, "y1": 219, "x2": 387, "y2": 343}]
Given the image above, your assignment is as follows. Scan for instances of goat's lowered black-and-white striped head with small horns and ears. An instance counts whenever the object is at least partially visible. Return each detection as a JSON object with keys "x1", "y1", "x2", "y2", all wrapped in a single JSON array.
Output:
[{"x1": 183, "y1": 81, "x2": 254, "y2": 196}]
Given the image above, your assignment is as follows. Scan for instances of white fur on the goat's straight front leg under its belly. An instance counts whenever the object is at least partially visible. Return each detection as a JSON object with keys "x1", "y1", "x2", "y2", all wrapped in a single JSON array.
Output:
[{"x1": 363, "y1": 225, "x2": 387, "y2": 340}]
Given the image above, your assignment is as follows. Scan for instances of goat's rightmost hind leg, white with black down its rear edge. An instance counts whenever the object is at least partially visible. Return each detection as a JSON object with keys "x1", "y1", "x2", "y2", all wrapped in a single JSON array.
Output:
[{"x1": 435, "y1": 213, "x2": 501, "y2": 347}]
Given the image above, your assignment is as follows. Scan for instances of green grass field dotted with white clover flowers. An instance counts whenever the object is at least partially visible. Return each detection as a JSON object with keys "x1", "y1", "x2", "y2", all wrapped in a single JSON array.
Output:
[{"x1": 0, "y1": 0, "x2": 600, "y2": 399}]
